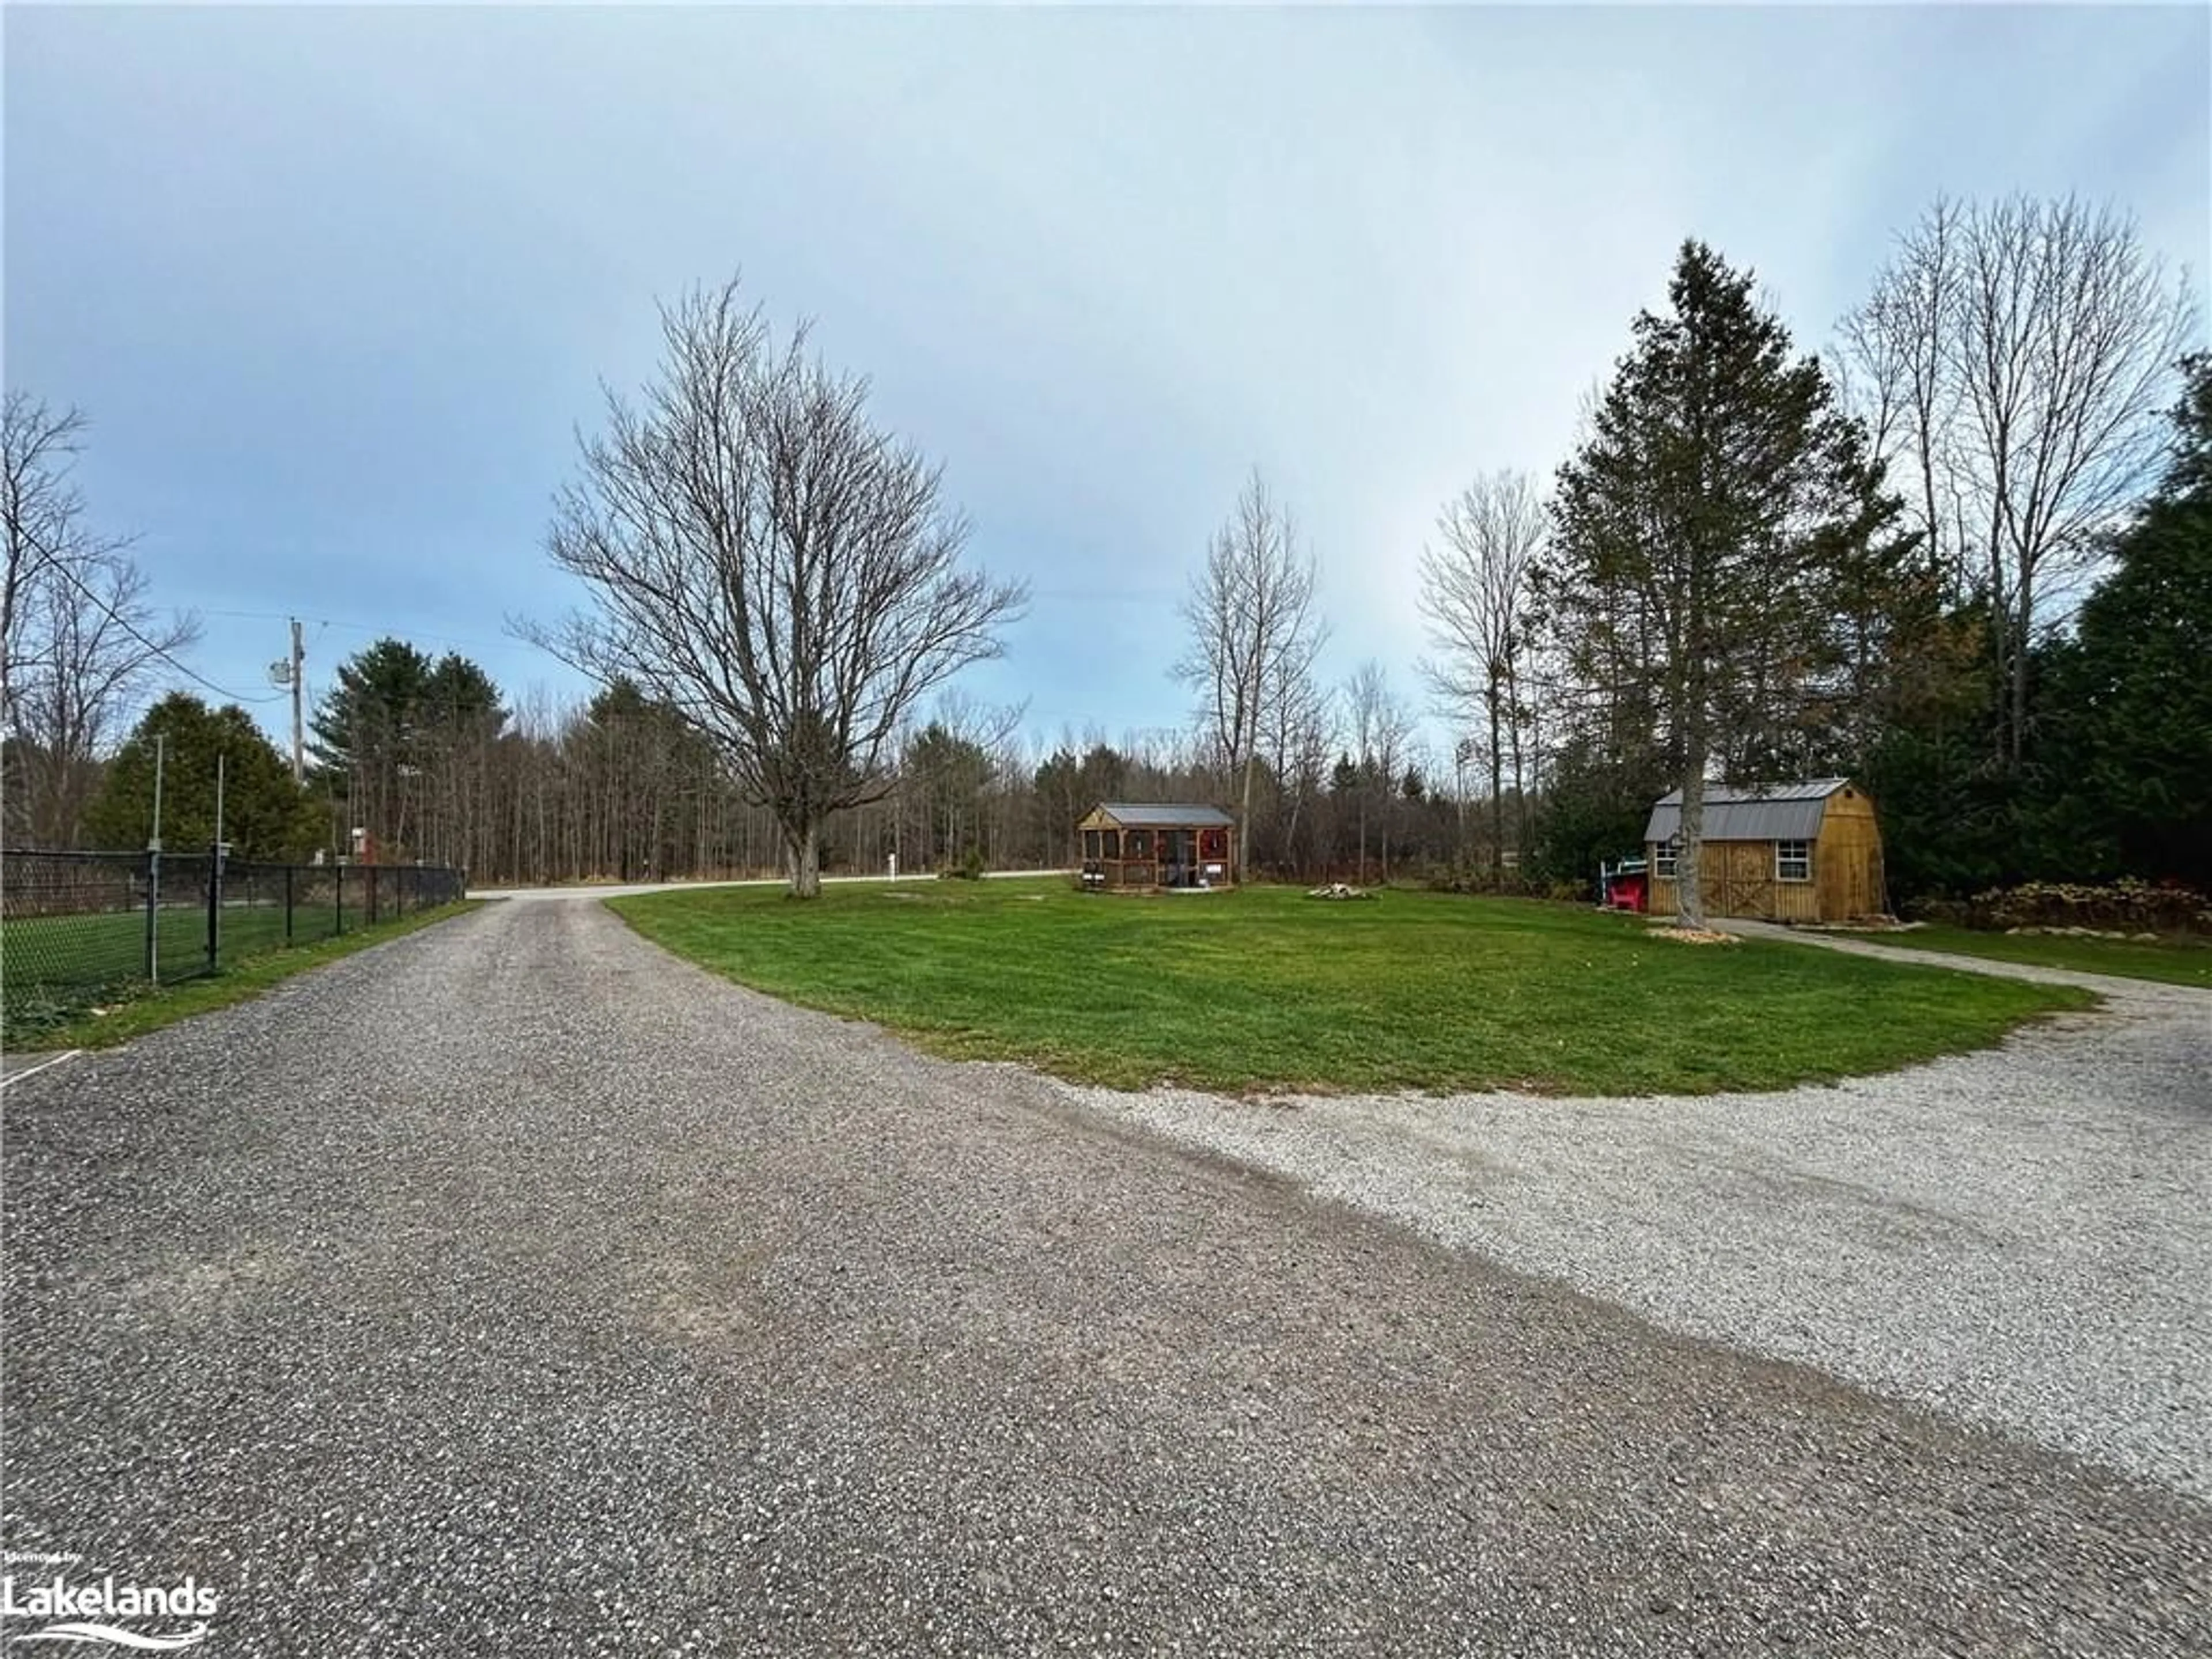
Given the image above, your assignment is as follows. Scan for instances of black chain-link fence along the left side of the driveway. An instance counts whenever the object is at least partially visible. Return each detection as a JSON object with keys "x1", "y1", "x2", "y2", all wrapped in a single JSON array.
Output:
[{"x1": 0, "y1": 851, "x2": 467, "y2": 1031}]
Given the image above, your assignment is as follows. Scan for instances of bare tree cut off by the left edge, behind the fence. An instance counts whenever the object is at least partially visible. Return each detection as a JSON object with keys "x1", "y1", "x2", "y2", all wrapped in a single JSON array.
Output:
[{"x1": 0, "y1": 389, "x2": 199, "y2": 847}]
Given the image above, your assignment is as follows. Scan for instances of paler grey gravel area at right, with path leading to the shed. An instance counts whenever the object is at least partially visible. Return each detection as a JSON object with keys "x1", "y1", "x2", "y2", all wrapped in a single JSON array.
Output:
[{"x1": 1071, "y1": 922, "x2": 2212, "y2": 1498}]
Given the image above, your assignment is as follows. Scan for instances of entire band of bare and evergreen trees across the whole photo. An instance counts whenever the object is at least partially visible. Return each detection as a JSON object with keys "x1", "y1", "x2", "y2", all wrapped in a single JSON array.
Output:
[{"x1": 0, "y1": 199, "x2": 2212, "y2": 920}]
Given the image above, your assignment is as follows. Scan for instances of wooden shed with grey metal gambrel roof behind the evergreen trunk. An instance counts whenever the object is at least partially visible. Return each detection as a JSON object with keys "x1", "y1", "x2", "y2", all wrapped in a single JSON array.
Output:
[{"x1": 1643, "y1": 779, "x2": 1889, "y2": 922}]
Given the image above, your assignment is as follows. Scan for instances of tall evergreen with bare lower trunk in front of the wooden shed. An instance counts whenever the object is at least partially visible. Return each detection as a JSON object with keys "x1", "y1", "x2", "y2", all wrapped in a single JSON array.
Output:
[{"x1": 1544, "y1": 241, "x2": 1902, "y2": 927}]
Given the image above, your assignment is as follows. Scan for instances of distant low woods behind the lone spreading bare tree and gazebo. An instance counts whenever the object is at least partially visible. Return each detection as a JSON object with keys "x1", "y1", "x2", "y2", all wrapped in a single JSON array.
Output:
[{"x1": 47, "y1": 639, "x2": 1458, "y2": 885}]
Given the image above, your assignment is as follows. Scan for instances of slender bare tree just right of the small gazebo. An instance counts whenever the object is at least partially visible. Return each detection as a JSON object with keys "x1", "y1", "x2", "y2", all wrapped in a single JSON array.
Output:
[{"x1": 1175, "y1": 469, "x2": 1327, "y2": 874}]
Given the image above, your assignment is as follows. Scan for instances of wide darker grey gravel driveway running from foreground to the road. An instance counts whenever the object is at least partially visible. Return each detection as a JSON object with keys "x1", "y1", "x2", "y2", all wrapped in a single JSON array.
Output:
[{"x1": 0, "y1": 903, "x2": 2212, "y2": 1657}]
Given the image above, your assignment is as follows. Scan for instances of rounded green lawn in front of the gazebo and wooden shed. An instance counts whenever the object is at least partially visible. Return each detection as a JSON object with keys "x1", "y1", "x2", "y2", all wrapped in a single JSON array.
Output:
[{"x1": 608, "y1": 880, "x2": 2093, "y2": 1095}]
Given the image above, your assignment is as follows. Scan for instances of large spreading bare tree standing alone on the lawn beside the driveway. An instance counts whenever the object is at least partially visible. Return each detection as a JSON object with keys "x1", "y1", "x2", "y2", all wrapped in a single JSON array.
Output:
[{"x1": 520, "y1": 281, "x2": 1027, "y2": 898}]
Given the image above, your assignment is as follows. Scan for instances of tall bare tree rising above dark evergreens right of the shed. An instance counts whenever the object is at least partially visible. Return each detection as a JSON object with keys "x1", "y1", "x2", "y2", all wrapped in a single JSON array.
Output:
[{"x1": 1840, "y1": 197, "x2": 2196, "y2": 767}]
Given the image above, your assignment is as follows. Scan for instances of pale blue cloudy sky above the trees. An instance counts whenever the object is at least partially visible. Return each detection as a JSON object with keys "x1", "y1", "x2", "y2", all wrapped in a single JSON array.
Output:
[{"x1": 5, "y1": 5, "x2": 2212, "y2": 760}]
